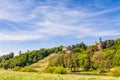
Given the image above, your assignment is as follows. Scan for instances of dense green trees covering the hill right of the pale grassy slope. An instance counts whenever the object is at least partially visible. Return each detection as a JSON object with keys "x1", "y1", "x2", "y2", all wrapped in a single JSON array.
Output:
[{"x1": 49, "y1": 39, "x2": 120, "y2": 72}]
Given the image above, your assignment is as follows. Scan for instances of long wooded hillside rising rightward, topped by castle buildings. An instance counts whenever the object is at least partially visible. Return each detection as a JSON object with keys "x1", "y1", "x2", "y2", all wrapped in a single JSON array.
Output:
[{"x1": 0, "y1": 38, "x2": 120, "y2": 75}]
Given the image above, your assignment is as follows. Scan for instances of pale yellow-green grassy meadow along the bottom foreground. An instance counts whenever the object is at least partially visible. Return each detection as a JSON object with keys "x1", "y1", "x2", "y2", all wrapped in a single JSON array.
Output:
[{"x1": 0, "y1": 70, "x2": 120, "y2": 80}]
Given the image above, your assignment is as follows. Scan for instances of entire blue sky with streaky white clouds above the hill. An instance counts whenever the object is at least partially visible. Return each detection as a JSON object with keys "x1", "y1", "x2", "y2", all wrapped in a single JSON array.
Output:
[{"x1": 0, "y1": 0, "x2": 120, "y2": 55}]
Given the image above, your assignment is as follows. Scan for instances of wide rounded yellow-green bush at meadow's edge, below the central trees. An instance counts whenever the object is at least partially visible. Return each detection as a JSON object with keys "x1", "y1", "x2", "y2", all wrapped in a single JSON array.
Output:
[{"x1": 43, "y1": 67, "x2": 68, "y2": 74}]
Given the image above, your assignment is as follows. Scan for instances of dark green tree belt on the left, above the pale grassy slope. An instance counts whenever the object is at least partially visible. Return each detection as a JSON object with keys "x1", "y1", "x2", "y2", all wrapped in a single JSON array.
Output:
[{"x1": 0, "y1": 46, "x2": 62, "y2": 69}]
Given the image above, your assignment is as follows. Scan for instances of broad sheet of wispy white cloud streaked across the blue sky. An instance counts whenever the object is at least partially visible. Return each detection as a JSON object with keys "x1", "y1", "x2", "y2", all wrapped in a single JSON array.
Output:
[{"x1": 0, "y1": 0, "x2": 120, "y2": 41}]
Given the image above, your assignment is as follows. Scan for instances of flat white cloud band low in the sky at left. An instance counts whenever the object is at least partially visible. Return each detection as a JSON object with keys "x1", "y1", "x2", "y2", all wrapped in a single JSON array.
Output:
[{"x1": 0, "y1": 32, "x2": 43, "y2": 41}]
